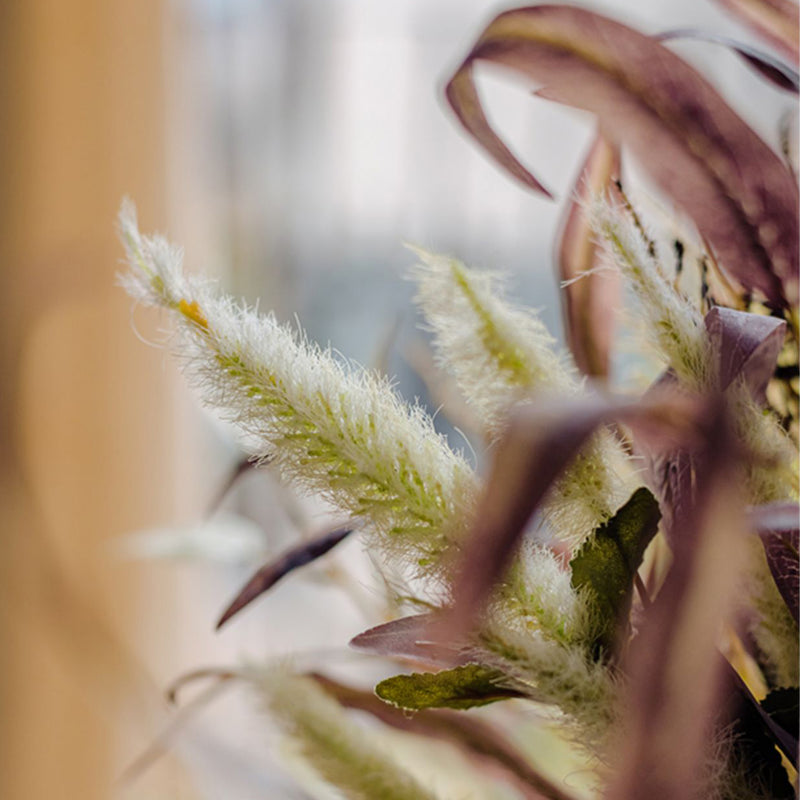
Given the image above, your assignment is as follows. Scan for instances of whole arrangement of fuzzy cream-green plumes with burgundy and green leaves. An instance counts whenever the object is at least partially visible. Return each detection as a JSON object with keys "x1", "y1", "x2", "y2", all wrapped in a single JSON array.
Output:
[{"x1": 119, "y1": 6, "x2": 800, "y2": 800}]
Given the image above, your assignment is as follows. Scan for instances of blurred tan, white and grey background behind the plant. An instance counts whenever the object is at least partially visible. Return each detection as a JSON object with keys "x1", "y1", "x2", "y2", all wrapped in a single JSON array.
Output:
[{"x1": 0, "y1": 0, "x2": 791, "y2": 800}]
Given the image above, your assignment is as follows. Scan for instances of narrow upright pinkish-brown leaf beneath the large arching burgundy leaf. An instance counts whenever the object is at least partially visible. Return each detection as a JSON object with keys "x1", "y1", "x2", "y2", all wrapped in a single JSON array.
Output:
[{"x1": 558, "y1": 135, "x2": 620, "y2": 378}]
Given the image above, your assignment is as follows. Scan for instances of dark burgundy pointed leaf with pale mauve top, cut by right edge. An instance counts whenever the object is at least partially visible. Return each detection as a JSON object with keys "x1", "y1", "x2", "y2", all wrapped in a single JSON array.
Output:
[{"x1": 750, "y1": 503, "x2": 800, "y2": 622}]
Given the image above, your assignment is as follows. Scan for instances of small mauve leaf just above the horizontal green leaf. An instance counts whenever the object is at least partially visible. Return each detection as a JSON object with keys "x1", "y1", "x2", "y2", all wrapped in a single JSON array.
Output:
[{"x1": 350, "y1": 613, "x2": 469, "y2": 667}]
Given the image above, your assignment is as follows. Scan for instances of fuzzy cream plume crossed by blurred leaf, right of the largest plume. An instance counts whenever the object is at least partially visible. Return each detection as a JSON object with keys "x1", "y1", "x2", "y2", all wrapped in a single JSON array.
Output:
[{"x1": 412, "y1": 250, "x2": 631, "y2": 545}]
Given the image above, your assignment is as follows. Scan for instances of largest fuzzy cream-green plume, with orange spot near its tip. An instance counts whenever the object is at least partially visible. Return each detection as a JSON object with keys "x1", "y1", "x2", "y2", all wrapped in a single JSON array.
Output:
[{"x1": 119, "y1": 203, "x2": 478, "y2": 588}]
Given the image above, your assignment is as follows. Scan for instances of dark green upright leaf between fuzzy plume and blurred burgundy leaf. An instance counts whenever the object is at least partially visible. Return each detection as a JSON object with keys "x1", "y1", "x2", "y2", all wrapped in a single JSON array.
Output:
[{"x1": 570, "y1": 487, "x2": 661, "y2": 657}]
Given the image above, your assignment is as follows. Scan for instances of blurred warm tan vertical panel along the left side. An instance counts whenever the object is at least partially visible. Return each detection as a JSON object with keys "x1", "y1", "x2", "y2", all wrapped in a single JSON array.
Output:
[{"x1": 0, "y1": 0, "x2": 194, "y2": 800}]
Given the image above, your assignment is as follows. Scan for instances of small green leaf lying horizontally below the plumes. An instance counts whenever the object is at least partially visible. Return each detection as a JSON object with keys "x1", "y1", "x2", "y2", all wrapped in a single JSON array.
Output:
[{"x1": 375, "y1": 664, "x2": 521, "y2": 711}]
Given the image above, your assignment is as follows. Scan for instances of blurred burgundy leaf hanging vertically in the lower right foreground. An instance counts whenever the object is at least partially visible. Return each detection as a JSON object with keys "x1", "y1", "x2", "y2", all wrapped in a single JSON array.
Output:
[{"x1": 608, "y1": 398, "x2": 747, "y2": 800}]
